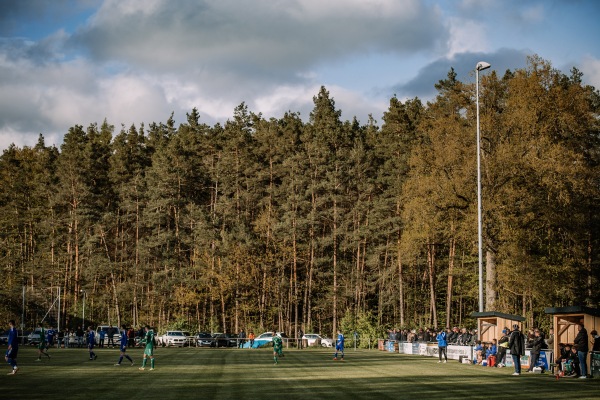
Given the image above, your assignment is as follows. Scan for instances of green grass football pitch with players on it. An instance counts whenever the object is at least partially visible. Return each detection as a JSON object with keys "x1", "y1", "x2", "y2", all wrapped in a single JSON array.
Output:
[{"x1": 0, "y1": 347, "x2": 600, "y2": 400}]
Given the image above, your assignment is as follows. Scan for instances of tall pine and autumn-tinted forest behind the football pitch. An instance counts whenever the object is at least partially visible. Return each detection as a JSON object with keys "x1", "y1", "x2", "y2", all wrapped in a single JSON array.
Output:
[{"x1": 0, "y1": 57, "x2": 600, "y2": 335}]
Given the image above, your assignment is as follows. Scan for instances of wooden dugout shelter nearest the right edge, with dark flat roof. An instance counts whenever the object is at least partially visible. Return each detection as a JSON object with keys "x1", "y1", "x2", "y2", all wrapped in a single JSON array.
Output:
[{"x1": 545, "y1": 306, "x2": 600, "y2": 366}]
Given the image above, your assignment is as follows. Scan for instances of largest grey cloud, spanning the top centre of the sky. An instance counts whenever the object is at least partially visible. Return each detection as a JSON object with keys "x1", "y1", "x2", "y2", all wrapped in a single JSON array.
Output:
[{"x1": 72, "y1": 0, "x2": 445, "y2": 74}]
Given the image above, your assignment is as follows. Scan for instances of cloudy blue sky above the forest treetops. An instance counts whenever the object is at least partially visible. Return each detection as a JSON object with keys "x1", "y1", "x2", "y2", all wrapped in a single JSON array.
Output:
[{"x1": 0, "y1": 0, "x2": 600, "y2": 150}]
